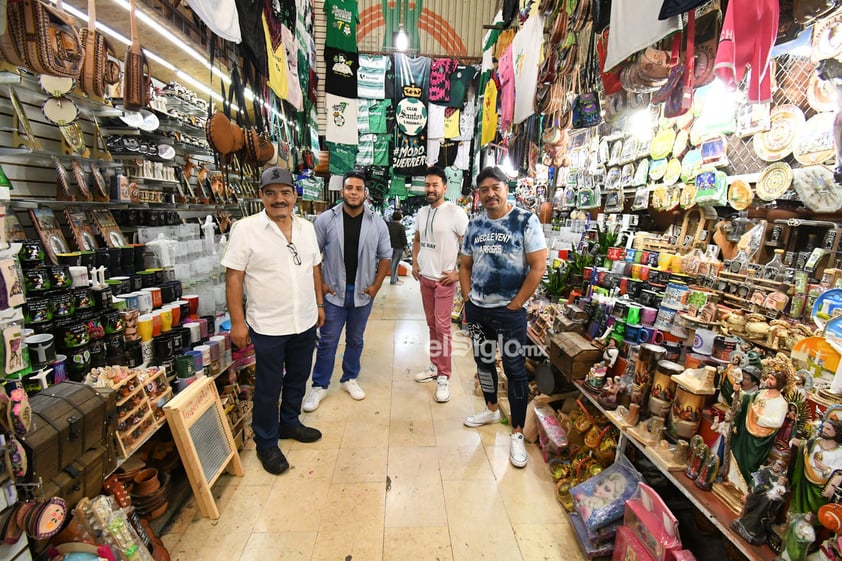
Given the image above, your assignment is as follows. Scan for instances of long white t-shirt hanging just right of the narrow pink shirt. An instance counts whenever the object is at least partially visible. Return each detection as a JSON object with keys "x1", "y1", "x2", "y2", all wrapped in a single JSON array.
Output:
[{"x1": 512, "y1": 13, "x2": 544, "y2": 123}]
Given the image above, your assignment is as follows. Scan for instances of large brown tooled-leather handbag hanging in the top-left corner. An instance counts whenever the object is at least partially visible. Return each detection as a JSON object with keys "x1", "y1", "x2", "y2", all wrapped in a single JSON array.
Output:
[{"x1": 0, "y1": 0, "x2": 82, "y2": 80}]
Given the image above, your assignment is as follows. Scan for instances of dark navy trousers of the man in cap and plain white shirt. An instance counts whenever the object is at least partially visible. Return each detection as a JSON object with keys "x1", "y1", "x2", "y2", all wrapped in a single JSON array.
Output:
[{"x1": 249, "y1": 325, "x2": 316, "y2": 448}]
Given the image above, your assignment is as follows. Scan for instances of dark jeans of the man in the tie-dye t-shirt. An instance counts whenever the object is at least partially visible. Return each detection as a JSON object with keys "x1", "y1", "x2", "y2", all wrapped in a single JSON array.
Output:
[{"x1": 465, "y1": 300, "x2": 529, "y2": 428}]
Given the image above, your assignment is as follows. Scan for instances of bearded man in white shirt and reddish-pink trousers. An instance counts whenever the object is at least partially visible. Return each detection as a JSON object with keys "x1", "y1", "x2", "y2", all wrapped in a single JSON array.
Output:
[{"x1": 412, "y1": 167, "x2": 468, "y2": 403}]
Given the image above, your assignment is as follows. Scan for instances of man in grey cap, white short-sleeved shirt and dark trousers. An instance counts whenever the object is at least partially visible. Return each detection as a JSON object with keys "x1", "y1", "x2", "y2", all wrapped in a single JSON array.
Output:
[{"x1": 222, "y1": 167, "x2": 325, "y2": 475}]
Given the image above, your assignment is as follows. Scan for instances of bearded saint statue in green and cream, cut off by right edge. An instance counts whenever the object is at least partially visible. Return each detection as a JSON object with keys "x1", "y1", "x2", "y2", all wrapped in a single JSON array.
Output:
[{"x1": 789, "y1": 409, "x2": 842, "y2": 514}]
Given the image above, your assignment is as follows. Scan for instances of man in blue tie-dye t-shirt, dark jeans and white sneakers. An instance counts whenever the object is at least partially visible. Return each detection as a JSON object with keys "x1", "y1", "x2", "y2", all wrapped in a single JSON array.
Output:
[{"x1": 459, "y1": 167, "x2": 547, "y2": 467}]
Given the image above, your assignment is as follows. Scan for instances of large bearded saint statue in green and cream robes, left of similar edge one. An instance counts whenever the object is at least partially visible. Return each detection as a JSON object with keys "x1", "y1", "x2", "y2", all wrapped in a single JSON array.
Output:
[{"x1": 730, "y1": 354, "x2": 795, "y2": 489}]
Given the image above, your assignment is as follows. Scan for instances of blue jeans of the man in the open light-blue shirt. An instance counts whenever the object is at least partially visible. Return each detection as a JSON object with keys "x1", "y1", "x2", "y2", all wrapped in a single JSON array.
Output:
[{"x1": 313, "y1": 286, "x2": 373, "y2": 388}]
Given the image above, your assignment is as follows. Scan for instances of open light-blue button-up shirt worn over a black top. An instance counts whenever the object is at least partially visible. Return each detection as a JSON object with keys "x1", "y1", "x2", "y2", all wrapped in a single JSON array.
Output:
[{"x1": 313, "y1": 203, "x2": 392, "y2": 307}]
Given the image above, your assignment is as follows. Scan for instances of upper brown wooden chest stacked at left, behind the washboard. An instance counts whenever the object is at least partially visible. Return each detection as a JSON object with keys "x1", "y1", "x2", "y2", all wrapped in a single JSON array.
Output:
[{"x1": 21, "y1": 381, "x2": 109, "y2": 481}]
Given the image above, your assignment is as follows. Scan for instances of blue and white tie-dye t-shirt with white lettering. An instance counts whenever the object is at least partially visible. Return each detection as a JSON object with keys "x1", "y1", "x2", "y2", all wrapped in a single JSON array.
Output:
[{"x1": 462, "y1": 207, "x2": 547, "y2": 308}]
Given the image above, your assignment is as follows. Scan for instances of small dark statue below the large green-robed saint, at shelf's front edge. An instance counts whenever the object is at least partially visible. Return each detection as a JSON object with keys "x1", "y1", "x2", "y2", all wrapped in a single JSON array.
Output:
[{"x1": 731, "y1": 460, "x2": 787, "y2": 545}]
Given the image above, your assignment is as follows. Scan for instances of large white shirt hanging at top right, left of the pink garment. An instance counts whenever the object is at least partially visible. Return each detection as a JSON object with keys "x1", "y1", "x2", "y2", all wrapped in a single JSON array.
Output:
[{"x1": 604, "y1": 0, "x2": 681, "y2": 72}]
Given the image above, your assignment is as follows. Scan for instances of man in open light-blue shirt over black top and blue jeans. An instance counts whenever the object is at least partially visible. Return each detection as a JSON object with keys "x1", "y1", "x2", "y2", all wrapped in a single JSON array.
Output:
[{"x1": 301, "y1": 171, "x2": 392, "y2": 411}]
